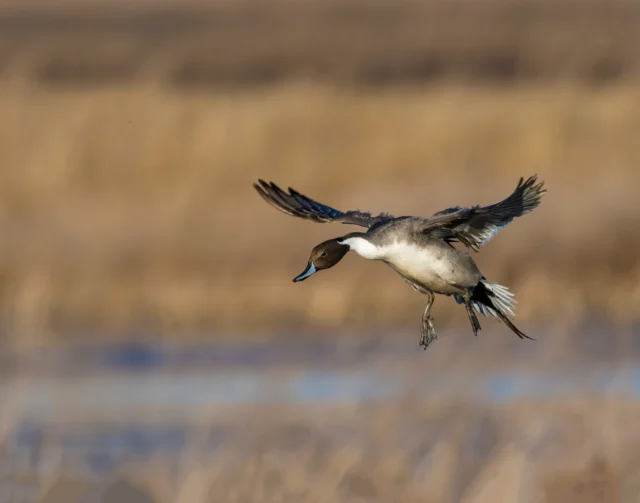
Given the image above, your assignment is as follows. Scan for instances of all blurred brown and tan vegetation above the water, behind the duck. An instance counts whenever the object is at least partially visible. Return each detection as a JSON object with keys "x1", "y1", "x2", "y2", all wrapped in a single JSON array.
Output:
[{"x1": 0, "y1": 1, "x2": 640, "y2": 341}]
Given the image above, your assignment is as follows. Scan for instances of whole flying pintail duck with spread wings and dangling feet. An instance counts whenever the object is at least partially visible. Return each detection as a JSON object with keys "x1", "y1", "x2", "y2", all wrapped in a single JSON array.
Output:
[{"x1": 253, "y1": 176, "x2": 546, "y2": 349}]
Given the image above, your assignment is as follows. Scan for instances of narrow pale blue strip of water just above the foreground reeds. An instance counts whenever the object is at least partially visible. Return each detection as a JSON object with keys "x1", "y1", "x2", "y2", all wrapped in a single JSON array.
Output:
[{"x1": 7, "y1": 366, "x2": 640, "y2": 417}]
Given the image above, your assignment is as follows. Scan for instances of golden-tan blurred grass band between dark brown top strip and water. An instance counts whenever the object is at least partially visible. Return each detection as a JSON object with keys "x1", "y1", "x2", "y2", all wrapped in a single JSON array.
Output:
[{"x1": 0, "y1": 83, "x2": 640, "y2": 346}]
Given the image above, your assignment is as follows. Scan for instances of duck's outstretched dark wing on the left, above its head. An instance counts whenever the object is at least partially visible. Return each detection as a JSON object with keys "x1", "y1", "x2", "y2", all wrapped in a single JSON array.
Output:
[{"x1": 253, "y1": 180, "x2": 393, "y2": 227}]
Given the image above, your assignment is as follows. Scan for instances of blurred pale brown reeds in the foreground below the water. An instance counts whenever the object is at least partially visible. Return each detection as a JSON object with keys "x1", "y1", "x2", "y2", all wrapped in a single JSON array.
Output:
[{"x1": 13, "y1": 397, "x2": 640, "y2": 503}]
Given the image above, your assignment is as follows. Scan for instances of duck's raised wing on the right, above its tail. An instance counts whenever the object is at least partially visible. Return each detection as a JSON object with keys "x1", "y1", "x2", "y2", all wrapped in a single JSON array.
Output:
[{"x1": 421, "y1": 175, "x2": 546, "y2": 251}]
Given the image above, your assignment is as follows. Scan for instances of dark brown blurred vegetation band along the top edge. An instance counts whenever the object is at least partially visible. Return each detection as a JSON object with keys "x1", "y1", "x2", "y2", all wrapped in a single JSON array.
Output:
[{"x1": 0, "y1": 0, "x2": 640, "y2": 90}]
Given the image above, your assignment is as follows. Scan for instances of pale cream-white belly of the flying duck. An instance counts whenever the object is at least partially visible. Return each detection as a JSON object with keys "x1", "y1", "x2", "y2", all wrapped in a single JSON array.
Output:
[{"x1": 385, "y1": 243, "x2": 482, "y2": 295}]
